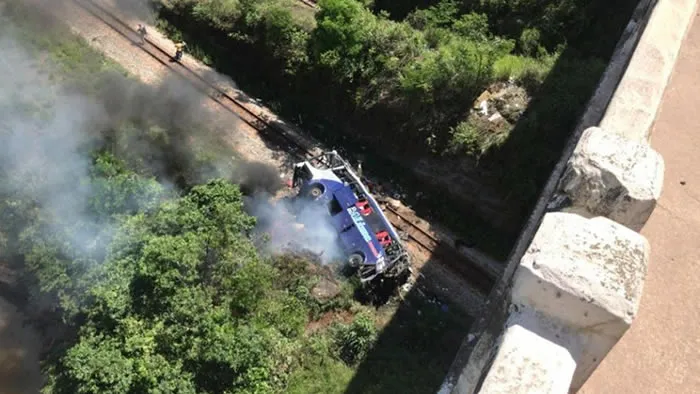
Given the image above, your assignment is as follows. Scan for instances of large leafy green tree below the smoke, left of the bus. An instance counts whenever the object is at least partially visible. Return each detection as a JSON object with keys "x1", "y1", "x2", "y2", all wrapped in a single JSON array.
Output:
[{"x1": 46, "y1": 180, "x2": 308, "y2": 393}]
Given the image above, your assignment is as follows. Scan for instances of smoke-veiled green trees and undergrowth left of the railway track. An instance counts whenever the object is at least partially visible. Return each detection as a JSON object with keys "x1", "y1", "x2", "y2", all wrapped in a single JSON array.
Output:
[{"x1": 0, "y1": 6, "x2": 465, "y2": 393}]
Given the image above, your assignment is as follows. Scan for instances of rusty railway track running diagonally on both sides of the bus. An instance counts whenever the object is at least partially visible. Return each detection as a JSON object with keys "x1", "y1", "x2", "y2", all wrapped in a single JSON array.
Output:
[{"x1": 73, "y1": 0, "x2": 495, "y2": 295}]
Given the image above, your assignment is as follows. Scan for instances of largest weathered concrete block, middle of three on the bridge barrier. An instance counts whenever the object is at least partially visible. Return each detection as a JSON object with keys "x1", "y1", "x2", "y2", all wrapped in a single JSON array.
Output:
[{"x1": 512, "y1": 212, "x2": 649, "y2": 390}]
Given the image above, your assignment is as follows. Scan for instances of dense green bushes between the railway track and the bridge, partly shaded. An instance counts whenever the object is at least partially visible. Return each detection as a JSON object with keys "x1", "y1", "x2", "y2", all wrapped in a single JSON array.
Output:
[{"x1": 161, "y1": 0, "x2": 635, "y2": 213}]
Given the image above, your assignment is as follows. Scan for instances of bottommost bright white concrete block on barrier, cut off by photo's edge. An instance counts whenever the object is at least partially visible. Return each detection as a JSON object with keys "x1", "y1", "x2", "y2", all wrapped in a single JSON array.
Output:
[{"x1": 479, "y1": 307, "x2": 578, "y2": 394}]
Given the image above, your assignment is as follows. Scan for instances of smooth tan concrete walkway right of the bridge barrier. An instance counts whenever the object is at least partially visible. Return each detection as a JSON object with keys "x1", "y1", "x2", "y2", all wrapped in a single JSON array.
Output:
[{"x1": 579, "y1": 6, "x2": 700, "y2": 394}]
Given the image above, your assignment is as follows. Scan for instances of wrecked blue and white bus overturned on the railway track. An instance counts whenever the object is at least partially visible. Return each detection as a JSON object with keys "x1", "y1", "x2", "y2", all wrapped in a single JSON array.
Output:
[{"x1": 291, "y1": 151, "x2": 410, "y2": 283}]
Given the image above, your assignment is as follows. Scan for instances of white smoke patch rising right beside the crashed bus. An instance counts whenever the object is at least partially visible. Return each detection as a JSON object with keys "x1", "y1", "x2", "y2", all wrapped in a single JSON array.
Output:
[{"x1": 246, "y1": 194, "x2": 343, "y2": 264}]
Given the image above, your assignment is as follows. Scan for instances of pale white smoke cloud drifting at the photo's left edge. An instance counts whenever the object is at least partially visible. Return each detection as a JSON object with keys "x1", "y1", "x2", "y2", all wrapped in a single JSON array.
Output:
[{"x1": 0, "y1": 36, "x2": 113, "y2": 254}]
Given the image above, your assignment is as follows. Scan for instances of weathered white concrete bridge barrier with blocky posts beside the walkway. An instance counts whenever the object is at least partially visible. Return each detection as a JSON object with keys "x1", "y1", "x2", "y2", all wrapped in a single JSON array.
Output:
[{"x1": 439, "y1": 0, "x2": 697, "y2": 394}]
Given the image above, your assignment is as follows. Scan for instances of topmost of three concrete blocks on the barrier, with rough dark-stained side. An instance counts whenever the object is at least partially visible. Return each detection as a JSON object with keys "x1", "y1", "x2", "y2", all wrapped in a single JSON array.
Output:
[{"x1": 559, "y1": 127, "x2": 664, "y2": 231}]
